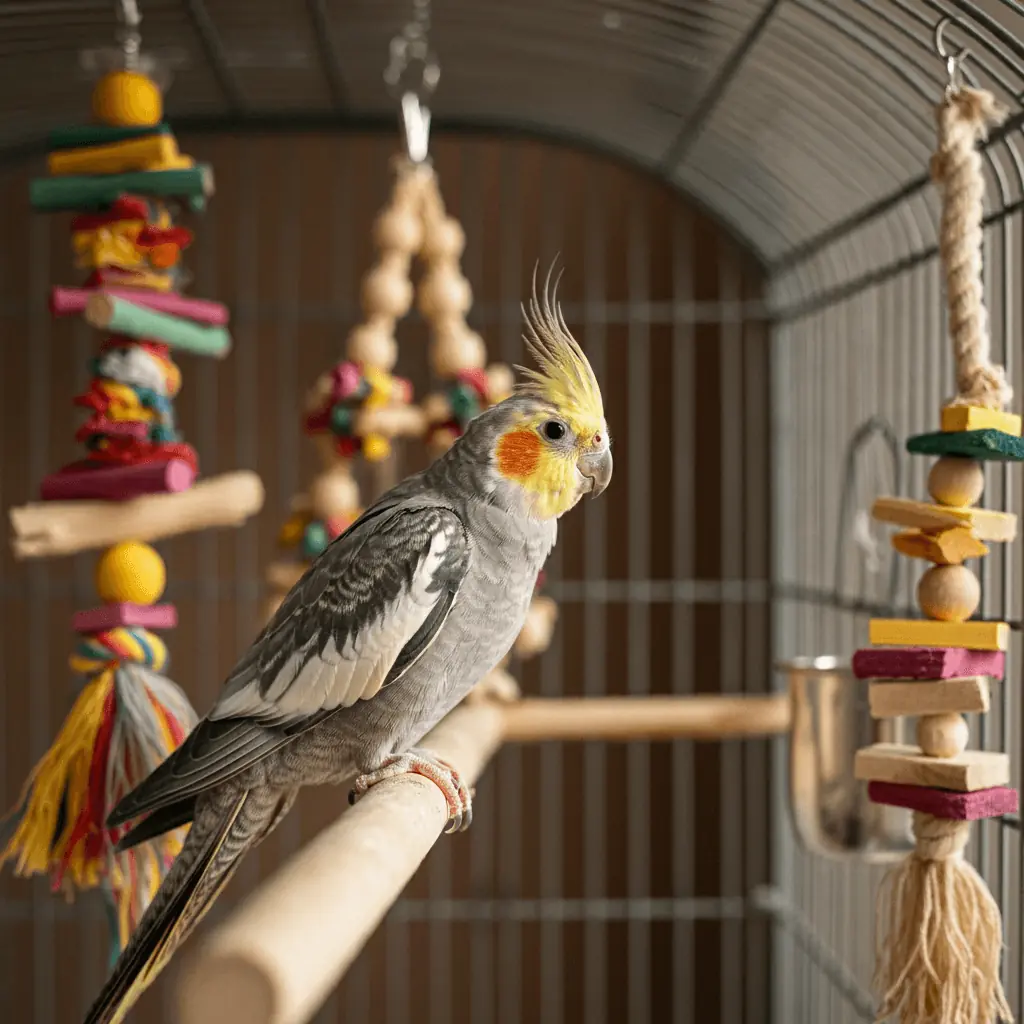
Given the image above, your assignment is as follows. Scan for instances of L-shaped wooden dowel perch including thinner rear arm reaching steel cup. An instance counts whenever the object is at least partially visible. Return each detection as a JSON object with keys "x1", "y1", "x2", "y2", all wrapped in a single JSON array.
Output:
[{"x1": 175, "y1": 694, "x2": 790, "y2": 1024}]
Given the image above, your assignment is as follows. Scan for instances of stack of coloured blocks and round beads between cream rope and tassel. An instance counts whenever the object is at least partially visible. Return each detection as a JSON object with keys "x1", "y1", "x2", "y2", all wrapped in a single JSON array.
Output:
[{"x1": 853, "y1": 407, "x2": 1024, "y2": 802}]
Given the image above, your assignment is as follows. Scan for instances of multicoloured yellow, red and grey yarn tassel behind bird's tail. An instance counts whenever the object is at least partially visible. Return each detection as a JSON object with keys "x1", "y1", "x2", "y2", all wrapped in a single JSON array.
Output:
[{"x1": 0, "y1": 662, "x2": 196, "y2": 949}]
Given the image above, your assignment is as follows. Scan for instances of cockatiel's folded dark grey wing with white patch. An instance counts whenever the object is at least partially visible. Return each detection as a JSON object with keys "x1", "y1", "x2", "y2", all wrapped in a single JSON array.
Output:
[{"x1": 108, "y1": 499, "x2": 469, "y2": 835}]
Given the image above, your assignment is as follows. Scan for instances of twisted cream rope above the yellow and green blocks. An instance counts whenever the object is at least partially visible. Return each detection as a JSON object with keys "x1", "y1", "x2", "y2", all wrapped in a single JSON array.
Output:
[{"x1": 932, "y1": 87, "x2": 1013, "y2": 410}]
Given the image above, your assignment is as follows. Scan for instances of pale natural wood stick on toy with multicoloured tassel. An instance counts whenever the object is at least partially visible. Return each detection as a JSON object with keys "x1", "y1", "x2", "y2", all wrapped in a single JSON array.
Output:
[{"x1": 9, "y1": 470, "x2": 263, "y2": 558}]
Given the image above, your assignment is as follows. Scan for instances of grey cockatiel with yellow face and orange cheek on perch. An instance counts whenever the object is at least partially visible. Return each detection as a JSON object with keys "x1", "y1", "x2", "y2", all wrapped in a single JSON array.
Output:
[{"x1": 86, "y1": 274, "x2": 611, "y2": 1024}]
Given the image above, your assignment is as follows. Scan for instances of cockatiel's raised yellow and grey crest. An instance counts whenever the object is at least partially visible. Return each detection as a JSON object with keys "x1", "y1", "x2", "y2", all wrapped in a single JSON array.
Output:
[{"x1": 516, "y1": 269, "x2": 604, "y2": 435}]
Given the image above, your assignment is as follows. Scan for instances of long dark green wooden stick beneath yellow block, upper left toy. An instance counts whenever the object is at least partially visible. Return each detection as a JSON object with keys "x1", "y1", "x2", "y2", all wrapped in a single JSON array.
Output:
[{"x1": 29, "y1": 164, "x2": 213, "y2": 213}]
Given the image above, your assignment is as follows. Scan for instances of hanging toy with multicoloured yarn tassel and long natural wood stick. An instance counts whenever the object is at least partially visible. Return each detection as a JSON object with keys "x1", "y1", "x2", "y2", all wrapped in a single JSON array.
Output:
[{"x1": 0, "y1": 54, "x2": 263, "y2": 951}]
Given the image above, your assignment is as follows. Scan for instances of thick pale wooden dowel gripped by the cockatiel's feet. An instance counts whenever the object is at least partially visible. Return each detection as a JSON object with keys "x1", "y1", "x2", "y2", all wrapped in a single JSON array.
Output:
[{"x1": 176, "y1": 707, "x2": 502, "y2": 1024}]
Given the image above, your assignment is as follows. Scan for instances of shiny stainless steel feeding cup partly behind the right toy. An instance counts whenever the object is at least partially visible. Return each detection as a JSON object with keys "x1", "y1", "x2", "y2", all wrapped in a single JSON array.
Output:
[{"x1": 776, "y1": 657, "x2": 913, "y2": 863}]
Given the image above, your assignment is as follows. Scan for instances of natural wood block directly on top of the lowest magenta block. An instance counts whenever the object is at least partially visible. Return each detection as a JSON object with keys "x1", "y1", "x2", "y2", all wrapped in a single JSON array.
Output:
[{"x1": 853, "y1": 743, "x2": 1010, "y2": 793}]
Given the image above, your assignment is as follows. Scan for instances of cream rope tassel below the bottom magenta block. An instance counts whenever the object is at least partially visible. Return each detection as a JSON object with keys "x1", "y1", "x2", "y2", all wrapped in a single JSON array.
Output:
[{"x1": 876, "y1": 811, "x2": 1013, "y2": 1024}]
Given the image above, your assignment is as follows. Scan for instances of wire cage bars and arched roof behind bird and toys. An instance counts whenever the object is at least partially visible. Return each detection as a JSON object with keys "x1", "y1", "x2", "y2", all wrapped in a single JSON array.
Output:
[{"x1": 0, "y1": 0, "x2": 1024, "y2": 1024}]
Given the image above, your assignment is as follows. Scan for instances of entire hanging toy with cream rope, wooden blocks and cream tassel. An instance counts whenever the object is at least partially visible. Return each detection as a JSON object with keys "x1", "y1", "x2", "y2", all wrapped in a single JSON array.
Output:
[{"x1": 853, "y1": 20, "x2": 1024, "y2": 1024}]
